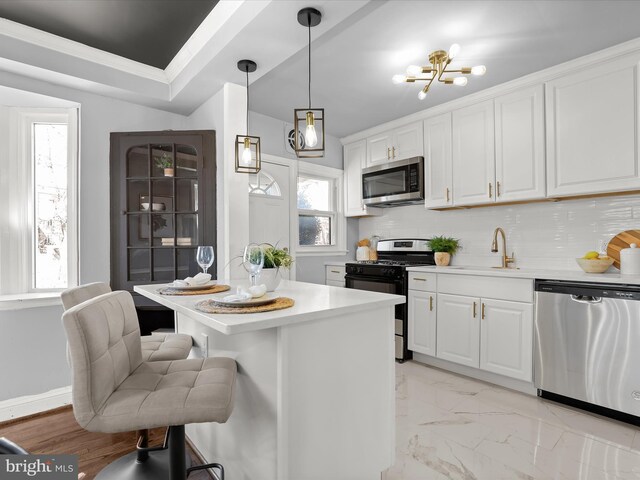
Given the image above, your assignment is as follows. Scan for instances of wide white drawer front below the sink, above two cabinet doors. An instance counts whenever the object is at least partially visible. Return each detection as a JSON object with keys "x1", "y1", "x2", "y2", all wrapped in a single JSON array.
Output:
[{"x1": 438, "y1": 274, "x2": 533, "y2": 303}]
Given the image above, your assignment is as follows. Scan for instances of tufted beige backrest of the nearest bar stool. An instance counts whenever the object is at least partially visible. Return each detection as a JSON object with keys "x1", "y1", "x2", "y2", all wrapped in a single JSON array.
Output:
[{"x1": 62, "y1": 291, "x2": 142, "y2": 427}]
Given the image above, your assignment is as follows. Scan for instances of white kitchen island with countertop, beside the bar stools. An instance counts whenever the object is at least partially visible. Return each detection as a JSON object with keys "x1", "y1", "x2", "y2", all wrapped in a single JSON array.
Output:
[{"x1": 134, "y1": 280, "x2": 405, "y2": 480}]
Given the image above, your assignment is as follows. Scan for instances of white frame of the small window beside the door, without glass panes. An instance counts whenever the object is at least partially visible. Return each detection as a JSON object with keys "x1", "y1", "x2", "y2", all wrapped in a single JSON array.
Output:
[{"x1": 292, "y1": 161, "x2": 347, "y2": 256}]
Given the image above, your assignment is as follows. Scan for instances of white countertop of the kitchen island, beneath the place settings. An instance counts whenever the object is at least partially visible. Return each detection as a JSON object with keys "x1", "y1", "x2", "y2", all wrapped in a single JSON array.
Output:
[{"x1": 133, "y1": 280, "x2": 406, "y2": 335}]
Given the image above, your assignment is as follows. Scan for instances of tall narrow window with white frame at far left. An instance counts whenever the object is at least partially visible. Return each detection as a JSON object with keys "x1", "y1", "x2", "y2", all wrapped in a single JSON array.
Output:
[{"x1": 0, "y1": 108, "x2": 77, "y2": 295}]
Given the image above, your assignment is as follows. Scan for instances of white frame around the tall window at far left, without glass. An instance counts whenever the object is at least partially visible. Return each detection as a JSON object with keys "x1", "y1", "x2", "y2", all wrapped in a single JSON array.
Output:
[{"x1": 0, "y1": 107, "x2": 79, "y2": 301}]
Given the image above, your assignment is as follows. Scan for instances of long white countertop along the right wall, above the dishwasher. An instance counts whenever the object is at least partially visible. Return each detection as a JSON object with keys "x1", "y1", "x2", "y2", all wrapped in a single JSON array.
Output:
[{"x1": 407, "y1": 265, "x2": 640, "y2": 285}]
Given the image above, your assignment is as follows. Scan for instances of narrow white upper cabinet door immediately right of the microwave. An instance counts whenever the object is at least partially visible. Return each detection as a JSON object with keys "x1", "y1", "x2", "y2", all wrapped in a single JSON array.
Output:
[{"x1": 424, "y1": 113, "x2": 453, "y2": 207}]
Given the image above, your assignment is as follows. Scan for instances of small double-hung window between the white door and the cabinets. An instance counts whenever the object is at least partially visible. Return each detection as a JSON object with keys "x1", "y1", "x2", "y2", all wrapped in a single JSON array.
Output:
[{"x1": 297, "y1": 162, "x2": 346, "y2": 255}]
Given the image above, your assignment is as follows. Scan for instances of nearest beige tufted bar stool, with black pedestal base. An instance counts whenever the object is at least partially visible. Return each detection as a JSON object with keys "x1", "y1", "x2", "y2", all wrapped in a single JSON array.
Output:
[{"x1": 62, "y1": 292, "x2": 237, "y2": 480}]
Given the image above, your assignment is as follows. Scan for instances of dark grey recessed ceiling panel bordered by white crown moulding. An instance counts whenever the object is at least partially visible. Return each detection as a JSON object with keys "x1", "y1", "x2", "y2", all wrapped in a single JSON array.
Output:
[{"x1": 0, "y1": 0, "x2": 218, "y2": 69}]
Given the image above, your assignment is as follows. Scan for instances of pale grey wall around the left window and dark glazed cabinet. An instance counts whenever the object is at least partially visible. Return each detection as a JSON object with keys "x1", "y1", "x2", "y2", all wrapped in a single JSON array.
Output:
[{"x1": 0, "y1": 72, "x2": 186, "y2": 401}]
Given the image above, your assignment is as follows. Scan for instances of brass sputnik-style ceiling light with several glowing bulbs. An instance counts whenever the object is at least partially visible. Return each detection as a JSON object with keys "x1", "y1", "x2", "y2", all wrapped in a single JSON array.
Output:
[{"x1": 392, "y1": 43, "x2": 487, "y2": 100}]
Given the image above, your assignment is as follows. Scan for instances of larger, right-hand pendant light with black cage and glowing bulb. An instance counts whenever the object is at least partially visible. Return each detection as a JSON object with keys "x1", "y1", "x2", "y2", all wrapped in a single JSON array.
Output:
[{"x1": 293, "y1": 8, "x2": 324, "y2": 158}]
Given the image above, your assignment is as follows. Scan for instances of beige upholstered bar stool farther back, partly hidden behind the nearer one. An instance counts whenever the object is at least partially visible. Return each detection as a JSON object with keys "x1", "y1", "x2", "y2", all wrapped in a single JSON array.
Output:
[{"x1": 60, "y1": 282, "x2": 193, "y2": 362}]
